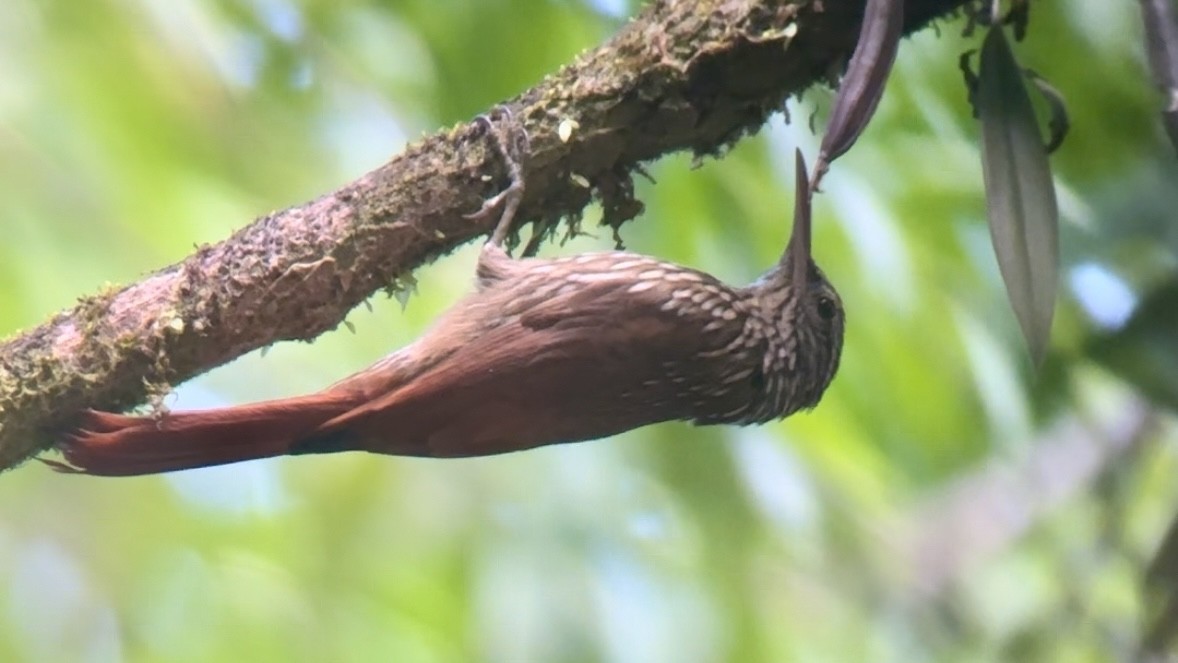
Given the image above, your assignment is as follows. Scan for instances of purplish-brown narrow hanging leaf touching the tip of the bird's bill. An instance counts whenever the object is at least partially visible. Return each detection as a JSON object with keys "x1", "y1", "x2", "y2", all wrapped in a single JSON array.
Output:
[{"x1": 810, "y1": 0, "x2": 904, "y2": 190}]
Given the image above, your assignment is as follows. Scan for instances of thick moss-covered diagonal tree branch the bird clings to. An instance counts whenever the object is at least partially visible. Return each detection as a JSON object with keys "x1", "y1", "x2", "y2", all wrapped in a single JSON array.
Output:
[{"x1": 0, "y1": 0, "x2": 965, "y2": 469}]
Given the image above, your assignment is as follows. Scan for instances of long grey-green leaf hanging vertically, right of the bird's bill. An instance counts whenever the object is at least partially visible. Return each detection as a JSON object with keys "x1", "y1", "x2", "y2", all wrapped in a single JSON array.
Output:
[{"x1": 975, "y1": 26, "x2": 1059, "y2": 365}]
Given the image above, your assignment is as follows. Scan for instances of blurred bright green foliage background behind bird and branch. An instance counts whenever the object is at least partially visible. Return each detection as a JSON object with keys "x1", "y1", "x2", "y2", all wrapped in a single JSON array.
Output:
[{"x1": 0, "y1": 0, "x2": 1178, "y2": 662}]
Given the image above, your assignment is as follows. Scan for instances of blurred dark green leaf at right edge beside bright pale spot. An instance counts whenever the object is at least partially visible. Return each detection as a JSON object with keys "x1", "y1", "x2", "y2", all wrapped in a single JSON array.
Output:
[{"x1": 1087, "y1": 277, "x2": 1178, "y2": 409}]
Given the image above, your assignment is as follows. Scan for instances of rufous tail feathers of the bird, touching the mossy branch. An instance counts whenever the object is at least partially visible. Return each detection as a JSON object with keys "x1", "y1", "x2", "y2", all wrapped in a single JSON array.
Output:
[{"x1": 42, "y1": 393, "x2": 352, "y2": 477}]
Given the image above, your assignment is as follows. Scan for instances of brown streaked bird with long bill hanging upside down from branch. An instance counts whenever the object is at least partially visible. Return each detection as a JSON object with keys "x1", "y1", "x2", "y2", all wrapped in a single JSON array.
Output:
[{"x1": 42, "y1": 117, "x2": 845, "y2": 476}]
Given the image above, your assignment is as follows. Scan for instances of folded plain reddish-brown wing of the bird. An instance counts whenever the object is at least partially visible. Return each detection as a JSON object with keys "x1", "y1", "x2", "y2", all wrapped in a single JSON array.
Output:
[{"x1": 306, "y1": 267, "x2": 736, "y2": 456}]
